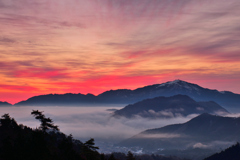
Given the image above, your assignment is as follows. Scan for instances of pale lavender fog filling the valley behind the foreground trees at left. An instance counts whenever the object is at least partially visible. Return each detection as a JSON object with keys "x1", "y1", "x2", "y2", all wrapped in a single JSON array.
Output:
[{"x1": 0, "y1": 106, "x2": 240, "y2": 153}]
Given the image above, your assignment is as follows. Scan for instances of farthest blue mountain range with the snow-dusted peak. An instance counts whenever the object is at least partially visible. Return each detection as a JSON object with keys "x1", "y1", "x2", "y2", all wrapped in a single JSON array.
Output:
[{"x1": 12, "y1": 80, "x2": 240, "y2": 107}]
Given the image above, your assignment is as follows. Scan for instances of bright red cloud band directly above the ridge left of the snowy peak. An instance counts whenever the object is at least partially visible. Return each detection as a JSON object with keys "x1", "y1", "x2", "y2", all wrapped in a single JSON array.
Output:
[{"x1": 46, "y1": 75, "x2": 167, "y2": 94}]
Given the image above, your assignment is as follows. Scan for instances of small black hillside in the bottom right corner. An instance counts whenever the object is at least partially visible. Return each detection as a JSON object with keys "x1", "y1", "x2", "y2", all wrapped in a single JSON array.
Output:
[{"x1": 204, "y1": 143, "x2": 240, "y2": 160}]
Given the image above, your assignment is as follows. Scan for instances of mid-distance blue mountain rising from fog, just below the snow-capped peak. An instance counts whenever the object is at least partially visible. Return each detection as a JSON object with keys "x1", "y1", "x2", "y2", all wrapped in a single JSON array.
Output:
[{"x1": 113, "y1": 95, "x2": 228, "y2": 118}]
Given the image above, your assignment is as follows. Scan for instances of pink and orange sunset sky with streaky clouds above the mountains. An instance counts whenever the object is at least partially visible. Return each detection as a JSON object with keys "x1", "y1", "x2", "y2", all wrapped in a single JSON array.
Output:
[{"x1": 0, "y1": 0, "x2": 240, "y2": 103}]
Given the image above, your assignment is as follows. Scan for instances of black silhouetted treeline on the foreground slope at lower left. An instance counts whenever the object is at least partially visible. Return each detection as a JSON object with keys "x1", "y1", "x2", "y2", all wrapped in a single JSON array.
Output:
[{"x1": 0, "y1": 110, "x2": 188, "y2": 160}]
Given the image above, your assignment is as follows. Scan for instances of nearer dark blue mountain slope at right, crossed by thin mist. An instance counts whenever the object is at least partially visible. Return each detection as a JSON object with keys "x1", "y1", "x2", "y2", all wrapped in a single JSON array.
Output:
[{"x1": 120, "y1": 113, "x2": 240, "y2": 150}]
